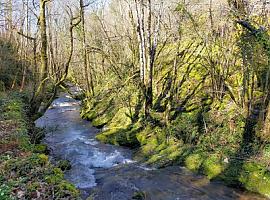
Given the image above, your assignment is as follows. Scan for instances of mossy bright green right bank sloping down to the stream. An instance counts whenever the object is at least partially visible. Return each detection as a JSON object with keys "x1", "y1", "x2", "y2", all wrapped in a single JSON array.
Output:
[{"x1": 81, "y1": 88, "x2": 270, "y2": 197}]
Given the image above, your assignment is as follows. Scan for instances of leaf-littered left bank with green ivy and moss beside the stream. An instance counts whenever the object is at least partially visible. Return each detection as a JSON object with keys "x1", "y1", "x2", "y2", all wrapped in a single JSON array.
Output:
[{"x1": 0, "y1": 92, "x2": 79, "y2": 200}]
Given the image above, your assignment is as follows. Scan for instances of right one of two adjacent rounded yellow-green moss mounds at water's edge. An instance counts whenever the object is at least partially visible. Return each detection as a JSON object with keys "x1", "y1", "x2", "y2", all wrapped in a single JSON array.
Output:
[{"x1": 202, "y1": 155, "x2": 224, "y2": 179}]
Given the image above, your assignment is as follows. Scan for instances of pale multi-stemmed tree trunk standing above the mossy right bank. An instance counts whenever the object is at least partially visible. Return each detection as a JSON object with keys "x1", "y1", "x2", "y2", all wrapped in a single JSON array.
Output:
[{"x1": 135, "y1": 0, "x2": 163, "y2": 117}]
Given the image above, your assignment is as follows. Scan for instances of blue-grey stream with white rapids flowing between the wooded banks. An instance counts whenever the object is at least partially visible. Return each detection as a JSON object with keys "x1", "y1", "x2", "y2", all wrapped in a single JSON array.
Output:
[{"x1": 36, "y1": 88, "x2": 264, "y2": 200}]
